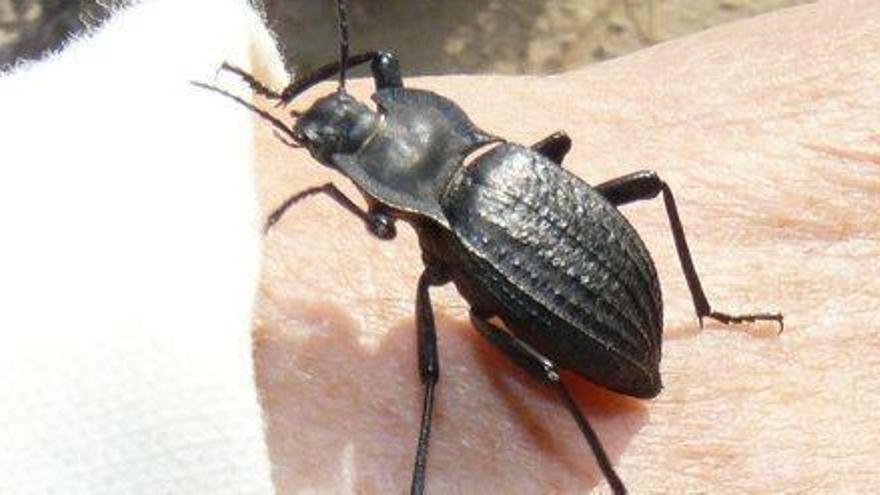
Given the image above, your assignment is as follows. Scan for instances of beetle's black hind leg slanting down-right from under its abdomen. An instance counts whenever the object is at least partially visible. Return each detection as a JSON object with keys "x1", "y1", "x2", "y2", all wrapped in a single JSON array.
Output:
[{"x1": 471, "y1": 310, "x2": 626, "y2": 495}]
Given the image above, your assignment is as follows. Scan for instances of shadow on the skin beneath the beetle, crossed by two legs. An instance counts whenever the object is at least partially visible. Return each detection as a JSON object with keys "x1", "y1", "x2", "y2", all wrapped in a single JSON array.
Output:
[{"x1": 254, "y1": 296, "x2": 647, "y2": 493}]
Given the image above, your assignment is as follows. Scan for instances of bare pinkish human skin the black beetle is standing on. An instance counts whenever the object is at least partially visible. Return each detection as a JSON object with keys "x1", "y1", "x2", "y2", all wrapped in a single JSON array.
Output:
[{"x1": 249, "y1": 1, "x2": 880, "y2": 493}]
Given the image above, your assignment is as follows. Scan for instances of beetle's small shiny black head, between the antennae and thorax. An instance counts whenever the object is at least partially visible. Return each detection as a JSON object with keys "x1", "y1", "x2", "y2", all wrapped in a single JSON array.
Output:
[{"x1": 293, "y1": 91, "x2": 379, "y2": 165}]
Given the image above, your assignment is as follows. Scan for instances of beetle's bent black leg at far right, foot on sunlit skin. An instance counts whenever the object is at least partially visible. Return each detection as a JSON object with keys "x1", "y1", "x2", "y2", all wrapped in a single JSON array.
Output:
[{"x1": 595, "y1": 170, "x2": 784, "y2": 332}]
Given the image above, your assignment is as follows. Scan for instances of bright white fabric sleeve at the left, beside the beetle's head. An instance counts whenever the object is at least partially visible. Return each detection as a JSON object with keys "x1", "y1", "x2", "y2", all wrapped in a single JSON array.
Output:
[{"x1": 0, "y1": 0, "x2": 284, "y2": 494}]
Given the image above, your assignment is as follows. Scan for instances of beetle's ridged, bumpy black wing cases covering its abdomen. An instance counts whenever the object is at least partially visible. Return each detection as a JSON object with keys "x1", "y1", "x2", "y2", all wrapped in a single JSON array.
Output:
[{"x1": 441, "y1": 144, "x2": 663, "y2": 397}]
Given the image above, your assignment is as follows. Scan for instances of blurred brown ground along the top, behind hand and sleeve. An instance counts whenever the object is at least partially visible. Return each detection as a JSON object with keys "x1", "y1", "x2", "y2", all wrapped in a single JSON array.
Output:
[{"x1": 0, "y1": 0, "x2": 813, "y2": 75}]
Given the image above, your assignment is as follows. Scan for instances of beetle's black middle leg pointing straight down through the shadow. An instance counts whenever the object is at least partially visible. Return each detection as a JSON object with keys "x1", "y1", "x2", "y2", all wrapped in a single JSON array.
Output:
[{"x1": 410, "y1": 268, "x2": 449, "y2": 495}]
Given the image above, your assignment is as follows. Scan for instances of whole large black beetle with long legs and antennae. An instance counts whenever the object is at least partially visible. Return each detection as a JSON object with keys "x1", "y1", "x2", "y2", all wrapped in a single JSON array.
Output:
[{"x1": 195, "y1": 0, "x2": 783, "y2": 494}]
